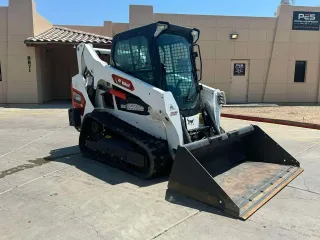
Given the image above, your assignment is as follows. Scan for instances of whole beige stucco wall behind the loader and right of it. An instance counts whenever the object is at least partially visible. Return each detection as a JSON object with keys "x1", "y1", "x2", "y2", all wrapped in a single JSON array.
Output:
[{"x1": 130, "y1": 5, "x2": 320, "y2": 102}]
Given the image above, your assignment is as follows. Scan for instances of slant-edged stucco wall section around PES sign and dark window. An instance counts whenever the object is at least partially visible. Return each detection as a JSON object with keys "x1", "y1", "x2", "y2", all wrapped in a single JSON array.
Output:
[{"x1": 265, "y1": 5, "x2": 320, "y2": 102}]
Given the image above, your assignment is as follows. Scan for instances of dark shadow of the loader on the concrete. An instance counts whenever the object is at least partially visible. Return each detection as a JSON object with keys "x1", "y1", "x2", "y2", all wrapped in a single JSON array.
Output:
[{"x1": 44, "y1": 146, "x2": 235, "y2": 219}]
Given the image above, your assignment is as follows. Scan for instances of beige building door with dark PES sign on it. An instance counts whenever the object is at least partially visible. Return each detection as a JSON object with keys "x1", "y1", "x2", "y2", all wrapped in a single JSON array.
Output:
[{"x1": 228, "y1": 60, "x2": 250, "y2": 103}]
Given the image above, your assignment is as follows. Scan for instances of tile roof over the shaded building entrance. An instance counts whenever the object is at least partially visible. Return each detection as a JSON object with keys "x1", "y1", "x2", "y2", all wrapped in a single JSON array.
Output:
[{"x1": 24, "y1": 26, "x2": 112, "y2": 45}]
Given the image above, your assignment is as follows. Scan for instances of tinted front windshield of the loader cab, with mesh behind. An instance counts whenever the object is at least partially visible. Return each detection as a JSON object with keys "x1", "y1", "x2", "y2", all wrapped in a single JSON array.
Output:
[{"x1": 157, "y1": 34, "x2": 198, "y2": 109}]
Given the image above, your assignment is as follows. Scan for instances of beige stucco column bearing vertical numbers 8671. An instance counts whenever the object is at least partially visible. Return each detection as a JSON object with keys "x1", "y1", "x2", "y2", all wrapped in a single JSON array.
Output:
[{"x1": 7, "y1": 0, "x2": 39, "y2": 103}]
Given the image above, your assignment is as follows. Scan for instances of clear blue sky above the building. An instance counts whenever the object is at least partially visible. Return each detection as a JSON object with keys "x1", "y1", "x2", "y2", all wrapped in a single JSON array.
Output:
[{"x1": 0, "y1": 0, "x2": 320, "y2": 26}]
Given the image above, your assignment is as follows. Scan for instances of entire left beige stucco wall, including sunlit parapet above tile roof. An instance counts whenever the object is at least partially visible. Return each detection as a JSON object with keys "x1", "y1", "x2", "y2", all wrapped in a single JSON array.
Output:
[{"x1": 0, "y1": 0, "x2": 52, "y2": 103}]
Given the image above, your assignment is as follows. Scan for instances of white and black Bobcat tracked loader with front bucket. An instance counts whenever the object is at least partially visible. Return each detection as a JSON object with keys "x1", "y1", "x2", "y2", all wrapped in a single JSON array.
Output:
[{"x1": 69, "y1": 22, "x2": 303, "y2": 219}]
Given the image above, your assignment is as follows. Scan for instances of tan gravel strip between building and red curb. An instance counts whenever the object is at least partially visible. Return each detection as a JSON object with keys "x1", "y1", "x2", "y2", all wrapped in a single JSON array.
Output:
[{"x1": 222, "y1": 106, "x2": 320, "y2": 124}]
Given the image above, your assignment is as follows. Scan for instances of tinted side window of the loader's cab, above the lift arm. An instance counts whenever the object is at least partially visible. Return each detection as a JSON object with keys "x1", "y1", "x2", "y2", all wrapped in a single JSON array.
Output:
[{"x1": 114, "y1": 36, "x2": 154, "y2": 85}]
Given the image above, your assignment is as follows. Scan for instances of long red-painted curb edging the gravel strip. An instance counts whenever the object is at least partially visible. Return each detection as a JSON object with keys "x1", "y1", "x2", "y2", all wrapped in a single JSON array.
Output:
[{"x1": 221, "y1": 113, "x2": 320, "y2": 130}]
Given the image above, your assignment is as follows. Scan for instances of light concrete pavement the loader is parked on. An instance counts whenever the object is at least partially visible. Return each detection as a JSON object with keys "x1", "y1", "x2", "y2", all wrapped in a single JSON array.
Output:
[{"x1": 0, "y1": 105, "x2": 320, "y2": 239}]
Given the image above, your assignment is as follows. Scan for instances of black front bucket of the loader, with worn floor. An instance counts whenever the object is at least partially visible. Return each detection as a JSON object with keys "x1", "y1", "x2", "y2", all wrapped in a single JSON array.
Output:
[{"x1": 168, "y1": 126, "x2": 303, "y2": 219}]
